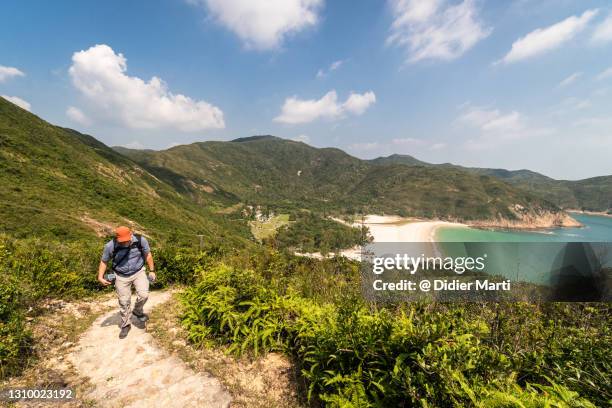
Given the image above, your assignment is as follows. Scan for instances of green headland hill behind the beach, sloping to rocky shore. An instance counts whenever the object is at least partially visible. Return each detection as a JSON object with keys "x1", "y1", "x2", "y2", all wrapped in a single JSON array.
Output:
[{"x1": 350, "y1": 164, "x2": 557, "y2": 220}]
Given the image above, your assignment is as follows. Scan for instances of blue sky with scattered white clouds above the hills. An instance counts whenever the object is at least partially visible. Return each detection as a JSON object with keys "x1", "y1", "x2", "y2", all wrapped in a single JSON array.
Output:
[{"x1": 0, "y1": 0, "x2": 612, "y2": 179}]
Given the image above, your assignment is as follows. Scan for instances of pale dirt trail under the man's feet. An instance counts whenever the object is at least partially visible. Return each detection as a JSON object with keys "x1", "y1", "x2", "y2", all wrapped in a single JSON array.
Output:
[{"x1": 67, "y1": 292, "x2": 231, "y2": 408}]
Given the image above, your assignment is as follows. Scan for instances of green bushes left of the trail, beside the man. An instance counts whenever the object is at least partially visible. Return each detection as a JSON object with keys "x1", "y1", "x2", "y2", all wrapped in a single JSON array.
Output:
[{"x1": 0, "y1": 235, "x2": 100, "y2": 379}]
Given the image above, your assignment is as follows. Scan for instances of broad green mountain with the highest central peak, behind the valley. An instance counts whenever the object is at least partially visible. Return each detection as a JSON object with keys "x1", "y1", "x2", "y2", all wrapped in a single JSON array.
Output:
[{"x1": 119, "y1": 136, "x2": 368, "y2": 208}]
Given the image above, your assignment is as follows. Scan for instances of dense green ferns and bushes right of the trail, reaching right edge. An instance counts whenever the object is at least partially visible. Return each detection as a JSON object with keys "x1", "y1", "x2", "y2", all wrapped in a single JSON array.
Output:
[{"x1": 184, "y1": 256, "x2": 612, "y2": 407}]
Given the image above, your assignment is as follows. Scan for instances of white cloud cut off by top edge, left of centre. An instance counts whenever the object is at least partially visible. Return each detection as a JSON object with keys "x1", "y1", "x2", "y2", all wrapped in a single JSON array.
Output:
[{"x1": 189, "y1": 0, "x2": 324, "y2": 50}]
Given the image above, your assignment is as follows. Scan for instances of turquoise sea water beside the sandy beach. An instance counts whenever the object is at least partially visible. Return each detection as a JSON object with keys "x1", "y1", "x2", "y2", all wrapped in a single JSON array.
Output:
[{"x1": 436, "y1": 214, "x2": 612, "y2": 285}]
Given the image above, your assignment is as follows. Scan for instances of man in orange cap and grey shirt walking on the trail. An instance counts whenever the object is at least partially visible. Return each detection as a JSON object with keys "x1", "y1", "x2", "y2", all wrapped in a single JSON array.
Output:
[{"x1": 98, "y1": 227, "x2": 156, "y2": 339}]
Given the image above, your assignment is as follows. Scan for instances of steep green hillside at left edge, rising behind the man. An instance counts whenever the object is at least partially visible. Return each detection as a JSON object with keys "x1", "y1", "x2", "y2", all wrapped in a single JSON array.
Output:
[{"x1": 0, "y1": 98, "x2": 248, "y2": 242}]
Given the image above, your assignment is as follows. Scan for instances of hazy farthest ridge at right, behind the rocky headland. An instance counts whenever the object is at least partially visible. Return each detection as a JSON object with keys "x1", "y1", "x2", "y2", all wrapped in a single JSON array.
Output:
[{"x1": 371, "y1": 154, "x2": 612, "y2": 212}]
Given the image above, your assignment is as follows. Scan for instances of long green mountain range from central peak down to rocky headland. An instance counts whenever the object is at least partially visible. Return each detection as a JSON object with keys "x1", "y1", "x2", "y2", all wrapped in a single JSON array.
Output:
[{"x1": 119, "y1": 136, "x2": 576, "y2": 226}]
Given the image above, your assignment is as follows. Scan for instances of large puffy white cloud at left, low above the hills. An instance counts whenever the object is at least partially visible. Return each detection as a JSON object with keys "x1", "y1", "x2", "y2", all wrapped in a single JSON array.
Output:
[{"x1": 69, "y1": 45, "x2": 225, "y2": 132}]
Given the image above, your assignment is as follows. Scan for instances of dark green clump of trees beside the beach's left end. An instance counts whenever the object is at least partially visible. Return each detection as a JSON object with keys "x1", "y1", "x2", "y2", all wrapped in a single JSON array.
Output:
[{"x1": 269, "y1": 211, "x2": 368, "y2": 255}]
